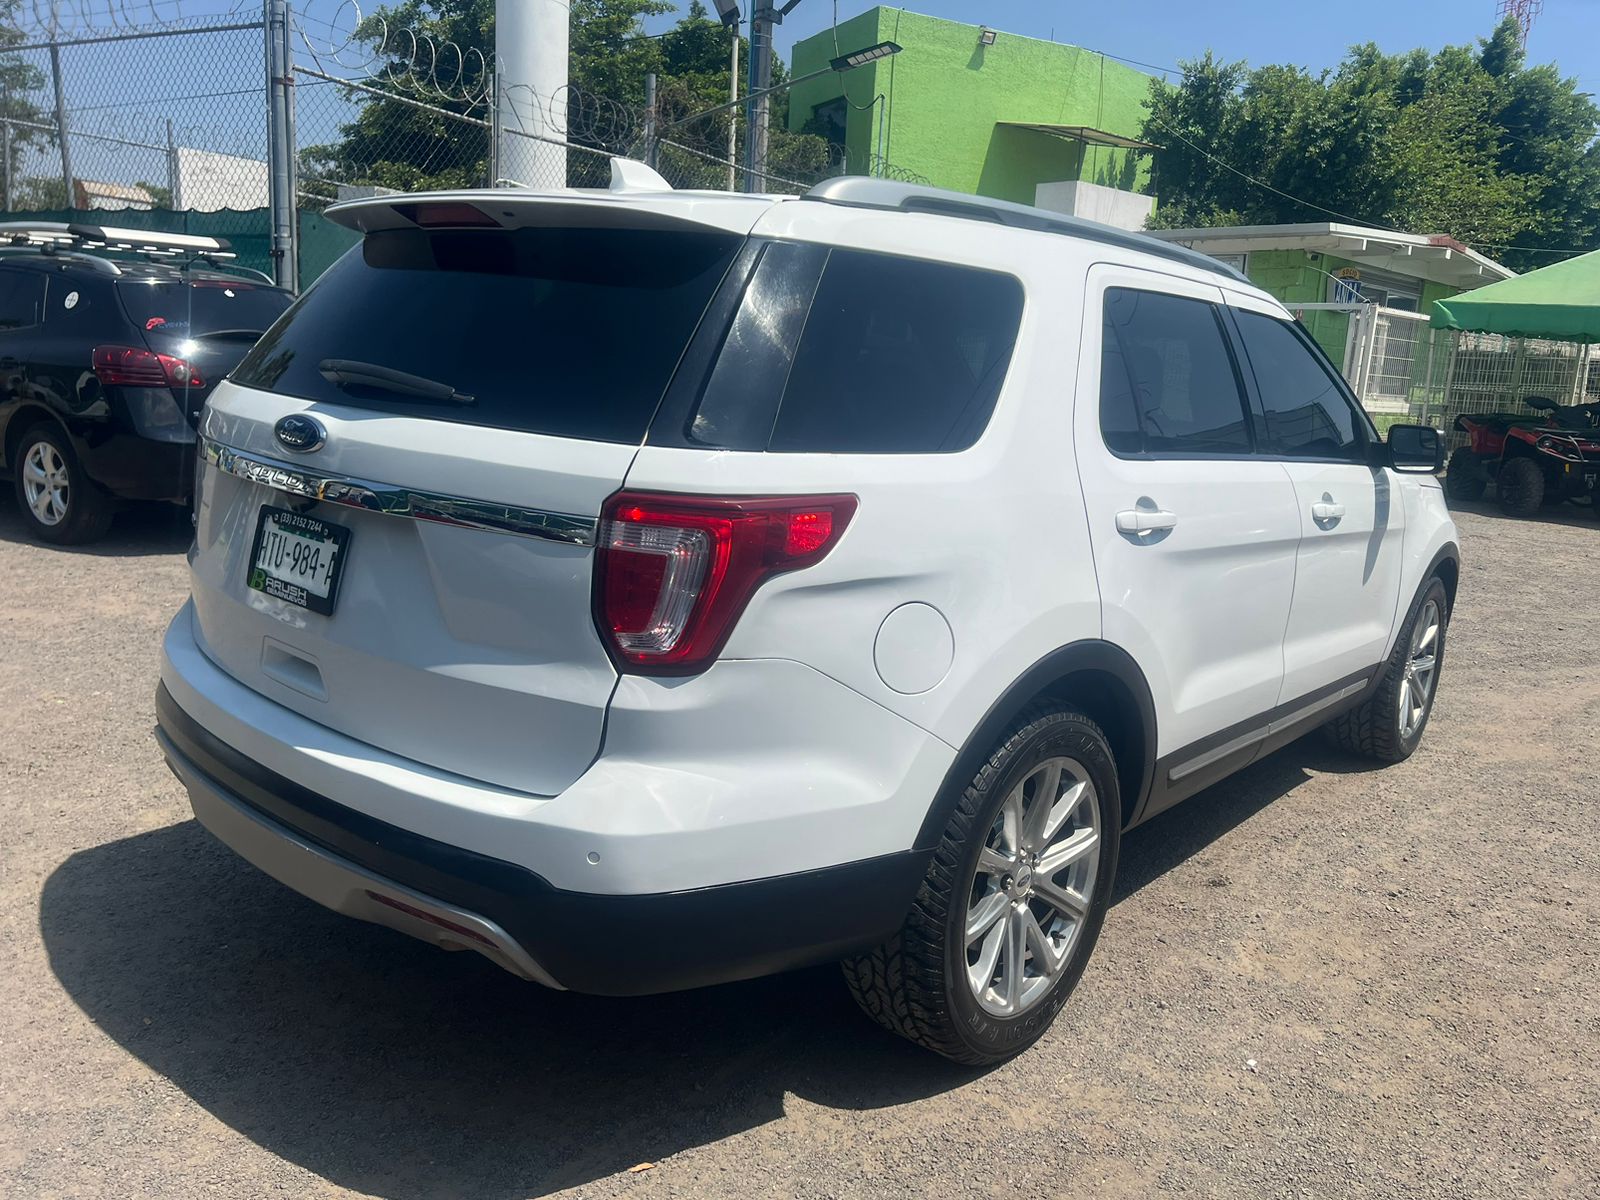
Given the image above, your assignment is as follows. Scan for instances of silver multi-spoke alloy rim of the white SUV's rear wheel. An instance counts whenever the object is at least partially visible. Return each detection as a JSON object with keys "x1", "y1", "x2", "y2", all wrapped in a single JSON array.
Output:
[{"x1": 965, "y1": 758, "x2": 1101, "y2": 1016}]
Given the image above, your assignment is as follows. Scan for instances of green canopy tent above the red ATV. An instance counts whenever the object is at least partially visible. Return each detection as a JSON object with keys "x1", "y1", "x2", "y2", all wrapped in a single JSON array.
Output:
[{"x1": 1432, "y1": 250, "x2": 1600, "y2": 342}]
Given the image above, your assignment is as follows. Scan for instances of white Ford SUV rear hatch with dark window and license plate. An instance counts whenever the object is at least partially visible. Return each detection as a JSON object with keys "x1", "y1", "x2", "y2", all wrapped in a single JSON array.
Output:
[{"x1": 192, "y1": 194, "x2": 758, "y2": 795}]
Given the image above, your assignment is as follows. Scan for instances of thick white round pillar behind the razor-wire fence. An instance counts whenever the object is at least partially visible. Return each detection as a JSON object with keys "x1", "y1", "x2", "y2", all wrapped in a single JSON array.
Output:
[{"x1": 494, "y1": 0, "x2": 571, "y2": 189}]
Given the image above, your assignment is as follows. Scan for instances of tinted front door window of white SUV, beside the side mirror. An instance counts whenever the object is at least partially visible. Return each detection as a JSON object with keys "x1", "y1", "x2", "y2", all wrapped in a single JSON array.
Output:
[{"x1": 1234, "y1": 310, "x2": 1365, "y2": 461}]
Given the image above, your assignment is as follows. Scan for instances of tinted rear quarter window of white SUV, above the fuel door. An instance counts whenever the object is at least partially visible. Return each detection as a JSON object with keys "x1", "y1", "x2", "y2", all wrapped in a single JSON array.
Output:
[{"x1": 690, "y1": 243, "x2": 1022, "y2": 454}]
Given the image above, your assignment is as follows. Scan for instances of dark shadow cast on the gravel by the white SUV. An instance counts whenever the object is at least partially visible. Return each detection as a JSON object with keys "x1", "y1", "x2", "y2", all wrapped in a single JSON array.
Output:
[{"x1": 40, "y1": 742, "x2": 1355, "y2": 1198}]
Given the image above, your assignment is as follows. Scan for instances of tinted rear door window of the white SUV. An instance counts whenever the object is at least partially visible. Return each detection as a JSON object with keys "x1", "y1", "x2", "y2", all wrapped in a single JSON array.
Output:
[{"x1": 1101, "y1": 288, "x2": 1251, "y2": 454}]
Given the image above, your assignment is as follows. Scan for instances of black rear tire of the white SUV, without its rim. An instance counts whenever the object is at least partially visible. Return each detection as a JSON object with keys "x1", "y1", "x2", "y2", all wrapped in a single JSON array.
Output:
[{"x1": 842, "y1": 704, "x2": 1122, "y2": 1066}]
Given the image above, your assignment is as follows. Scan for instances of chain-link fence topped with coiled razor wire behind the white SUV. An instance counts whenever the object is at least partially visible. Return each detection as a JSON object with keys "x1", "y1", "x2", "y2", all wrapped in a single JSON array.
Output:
[{"x1": 0, "y1": 0, "x2": 920, "y2": 291}]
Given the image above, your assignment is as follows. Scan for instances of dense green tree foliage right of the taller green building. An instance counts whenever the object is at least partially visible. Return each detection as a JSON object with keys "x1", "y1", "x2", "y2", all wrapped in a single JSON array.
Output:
[{"x1": 1144, "y1": 21, "x2": 1600, "y2": 269}]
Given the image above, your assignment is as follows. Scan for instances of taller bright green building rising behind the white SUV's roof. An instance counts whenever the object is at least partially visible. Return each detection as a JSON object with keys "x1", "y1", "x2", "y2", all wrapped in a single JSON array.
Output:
[{"x1": 789, "y1": 8, "x2": 1150, "y2": 229}]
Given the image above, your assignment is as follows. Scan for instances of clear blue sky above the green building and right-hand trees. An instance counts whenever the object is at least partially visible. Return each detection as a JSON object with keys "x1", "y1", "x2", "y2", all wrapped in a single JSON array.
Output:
[{"x1": 685, "y1": 0, "x2": 1600, "y2": 94}]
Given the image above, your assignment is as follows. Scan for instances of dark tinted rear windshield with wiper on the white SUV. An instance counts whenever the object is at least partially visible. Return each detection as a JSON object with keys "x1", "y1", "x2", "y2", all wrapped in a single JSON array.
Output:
[{"x1": 234, "y1": 229, "x2": 742, "y2": 442}]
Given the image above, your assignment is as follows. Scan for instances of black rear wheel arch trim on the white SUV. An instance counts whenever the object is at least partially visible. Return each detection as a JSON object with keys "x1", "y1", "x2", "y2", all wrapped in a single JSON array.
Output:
[{"x1": 917, "y1": 640, "x2": 1155, "y2": 850}]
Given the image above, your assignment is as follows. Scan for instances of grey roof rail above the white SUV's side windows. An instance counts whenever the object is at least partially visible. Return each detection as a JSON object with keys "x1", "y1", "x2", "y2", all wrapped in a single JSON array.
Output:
[{"x1": 800, "y1": 174, "x2": 1250, "y2": 283}]
